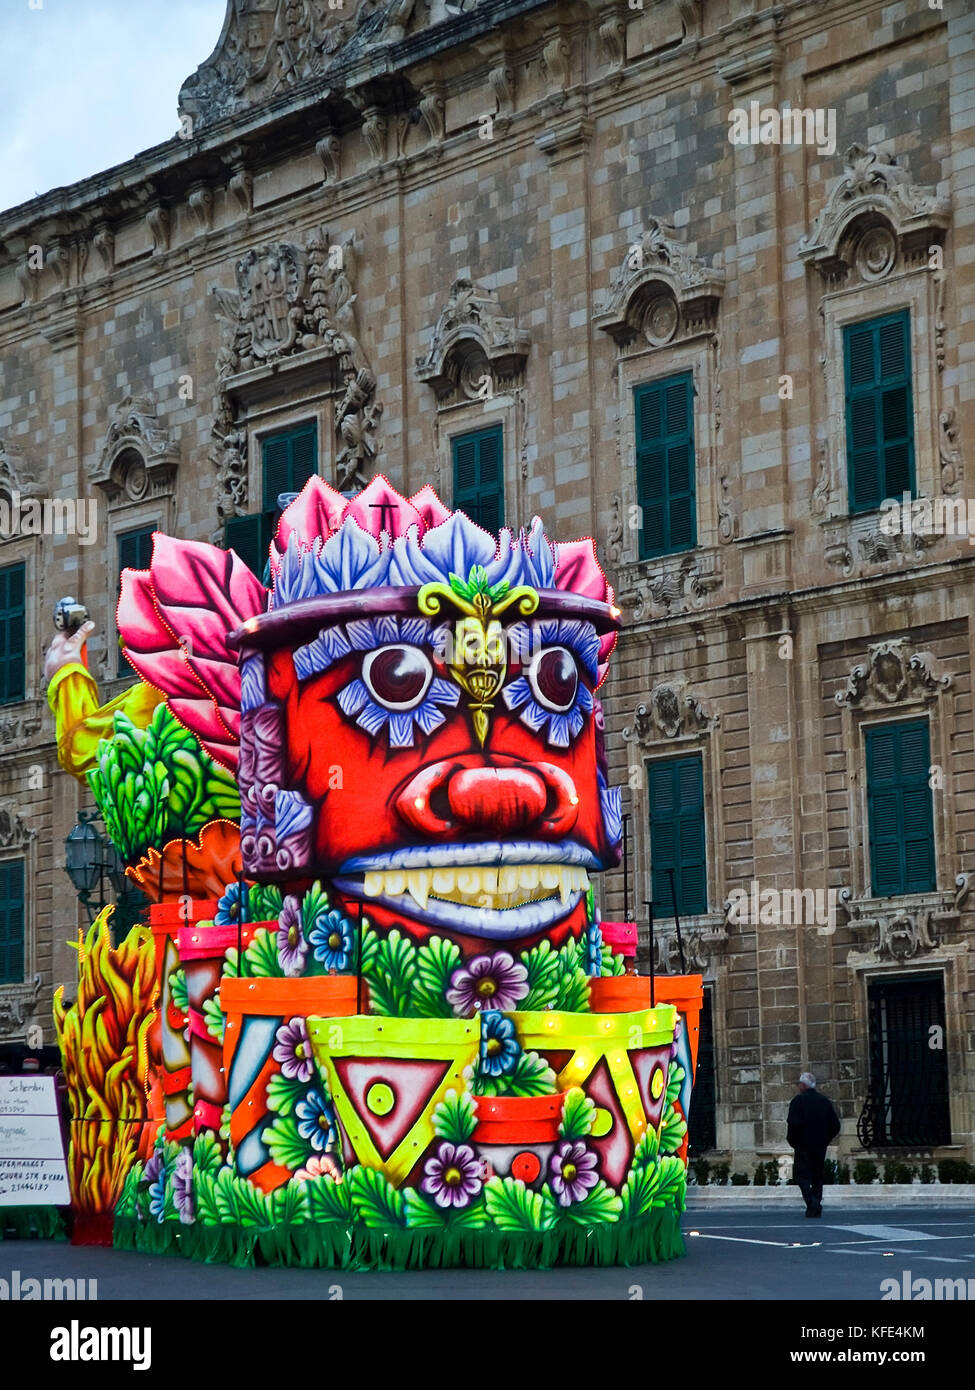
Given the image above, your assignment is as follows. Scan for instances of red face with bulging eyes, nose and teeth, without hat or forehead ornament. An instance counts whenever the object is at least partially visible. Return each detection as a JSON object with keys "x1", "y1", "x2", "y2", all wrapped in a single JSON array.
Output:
[{"x1": 257, "y1": 619, "x2": 613, "y2": 940}]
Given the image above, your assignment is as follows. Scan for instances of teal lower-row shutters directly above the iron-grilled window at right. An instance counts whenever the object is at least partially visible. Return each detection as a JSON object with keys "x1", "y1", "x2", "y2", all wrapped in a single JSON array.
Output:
[{"x1": 867, "y1": 719, "x2": 936, "y2": 898}]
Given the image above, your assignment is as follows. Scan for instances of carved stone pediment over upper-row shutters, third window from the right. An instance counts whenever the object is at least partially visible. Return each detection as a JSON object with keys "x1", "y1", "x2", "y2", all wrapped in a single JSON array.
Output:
[{"x1": 416, "y1": 279, "x2": 531, "y2": 400}]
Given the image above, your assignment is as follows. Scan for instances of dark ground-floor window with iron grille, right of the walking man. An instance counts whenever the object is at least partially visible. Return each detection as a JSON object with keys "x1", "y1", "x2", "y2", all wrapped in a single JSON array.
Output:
[{"x1": 857, "y1": 976, "x2": 951, "y2": 1148}]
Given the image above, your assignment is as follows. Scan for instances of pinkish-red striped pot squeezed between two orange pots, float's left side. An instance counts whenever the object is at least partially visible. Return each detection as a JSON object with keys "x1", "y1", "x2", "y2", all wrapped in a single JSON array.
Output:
[{"x1": 178, "y1": 922, "x2": 254, "y2": 1134}]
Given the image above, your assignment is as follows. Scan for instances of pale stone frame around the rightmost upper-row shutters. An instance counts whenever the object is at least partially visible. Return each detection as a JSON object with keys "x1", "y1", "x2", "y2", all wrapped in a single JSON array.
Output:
[{"x1": 816, "y1": 265, "x2": 943, "y2": 530}]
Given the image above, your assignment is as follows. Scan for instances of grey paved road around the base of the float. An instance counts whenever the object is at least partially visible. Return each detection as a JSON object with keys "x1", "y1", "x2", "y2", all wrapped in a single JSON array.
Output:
[{"x1": 7, "y1": 1207, "x2": 975, "y2": 1314}]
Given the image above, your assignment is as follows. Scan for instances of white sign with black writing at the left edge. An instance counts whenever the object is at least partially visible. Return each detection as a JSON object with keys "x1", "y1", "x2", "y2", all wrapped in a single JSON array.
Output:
[{"x1": 0, "y1": 1076, "x2": 71, "y2": 1207}]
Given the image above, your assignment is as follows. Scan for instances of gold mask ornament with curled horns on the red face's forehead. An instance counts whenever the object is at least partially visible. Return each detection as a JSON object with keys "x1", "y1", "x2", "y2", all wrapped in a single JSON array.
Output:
[{"x1": 417, "y1": 564, "x2": 538, "y2": 748}]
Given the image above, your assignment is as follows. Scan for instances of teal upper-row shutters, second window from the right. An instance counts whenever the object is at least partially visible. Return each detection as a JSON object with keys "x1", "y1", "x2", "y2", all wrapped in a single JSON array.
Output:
[{"x1": 634, "y1": 373, "x2": 697, "y2": 560}]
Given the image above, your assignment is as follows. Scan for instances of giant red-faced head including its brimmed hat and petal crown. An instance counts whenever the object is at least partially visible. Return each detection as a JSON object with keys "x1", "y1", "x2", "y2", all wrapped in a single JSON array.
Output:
[{"x1": 238, "y1": 480, "x2": 619, "y2": 940}]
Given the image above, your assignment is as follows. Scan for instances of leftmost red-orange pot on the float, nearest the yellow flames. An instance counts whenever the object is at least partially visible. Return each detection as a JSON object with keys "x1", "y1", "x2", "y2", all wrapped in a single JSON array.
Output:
[{"x1": 149, "y1": 897, "x2": 217, "y2": 1140}]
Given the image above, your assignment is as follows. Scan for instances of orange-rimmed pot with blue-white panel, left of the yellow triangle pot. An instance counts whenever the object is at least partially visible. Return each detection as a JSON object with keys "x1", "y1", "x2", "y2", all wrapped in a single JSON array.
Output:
[{"x1": 220, "y1": 978, "x2": 356, "y2": 1193}]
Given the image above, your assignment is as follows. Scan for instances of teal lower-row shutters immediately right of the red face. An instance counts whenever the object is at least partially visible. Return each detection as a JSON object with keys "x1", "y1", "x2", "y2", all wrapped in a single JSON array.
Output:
[{"x1": 647, "y1": 756, "x2": 708, "y2": 917}]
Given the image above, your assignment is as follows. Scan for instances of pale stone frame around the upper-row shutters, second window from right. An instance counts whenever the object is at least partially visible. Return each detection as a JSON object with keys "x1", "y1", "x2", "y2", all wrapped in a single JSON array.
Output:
[{"x1": 615, "y1": 329, "x2": 720, "y2": 571}]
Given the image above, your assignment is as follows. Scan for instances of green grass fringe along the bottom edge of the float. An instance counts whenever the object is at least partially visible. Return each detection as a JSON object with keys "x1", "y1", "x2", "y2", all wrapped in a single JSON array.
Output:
[{"x1": 114, "y1": 1207, "x2": 684, "y2": 1269}]
